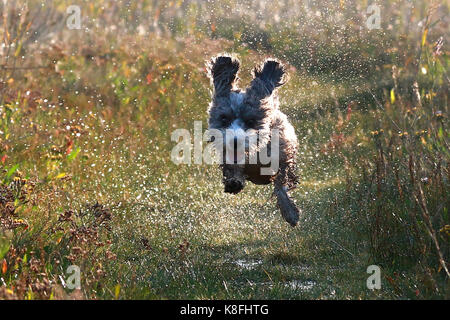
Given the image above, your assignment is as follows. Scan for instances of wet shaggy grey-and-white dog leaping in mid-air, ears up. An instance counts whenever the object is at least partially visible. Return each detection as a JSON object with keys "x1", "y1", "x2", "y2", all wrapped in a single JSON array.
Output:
[{"x1": 207, "y1": 54, "x2": 300, "y2": 226}]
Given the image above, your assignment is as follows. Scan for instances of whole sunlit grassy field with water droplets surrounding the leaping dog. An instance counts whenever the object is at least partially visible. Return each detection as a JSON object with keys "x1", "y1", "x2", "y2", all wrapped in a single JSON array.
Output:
[{"x1": 0, "y1": 0, "x2": 450, "y2": 299}]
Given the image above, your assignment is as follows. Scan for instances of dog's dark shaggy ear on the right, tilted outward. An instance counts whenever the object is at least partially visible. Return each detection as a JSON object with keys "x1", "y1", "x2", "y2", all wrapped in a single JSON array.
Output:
[{"x1": 249, "y1": 59, "x2": 287, "y2": 99}]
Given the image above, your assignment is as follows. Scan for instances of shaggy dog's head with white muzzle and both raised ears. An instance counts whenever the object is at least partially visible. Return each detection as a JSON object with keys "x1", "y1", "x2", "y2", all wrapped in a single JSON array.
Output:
[{"x1": 208, "y1": 55, "x2": 286, "y2": 163}]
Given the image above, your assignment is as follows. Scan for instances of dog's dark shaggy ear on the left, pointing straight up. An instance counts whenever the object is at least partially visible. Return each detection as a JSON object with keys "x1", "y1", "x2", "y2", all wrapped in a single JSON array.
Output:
[{"x1": 207, "y1": 55, "x2": 240, "y2": 96}]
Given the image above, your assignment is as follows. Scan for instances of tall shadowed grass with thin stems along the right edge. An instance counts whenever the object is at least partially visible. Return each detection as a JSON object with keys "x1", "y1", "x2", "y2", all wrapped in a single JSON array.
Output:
[{"x1": 360, "y1": 8, "x2": 450, "y2": 297}]
